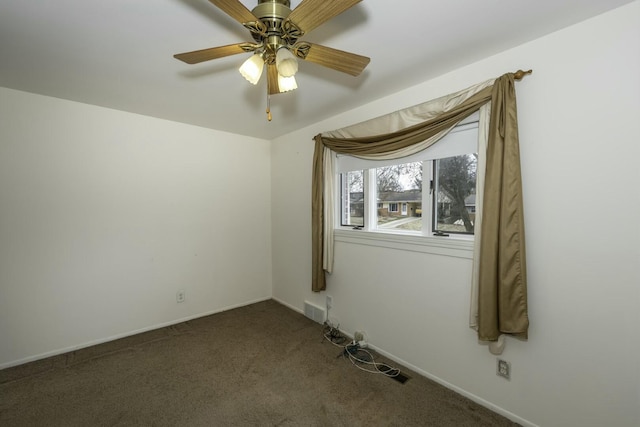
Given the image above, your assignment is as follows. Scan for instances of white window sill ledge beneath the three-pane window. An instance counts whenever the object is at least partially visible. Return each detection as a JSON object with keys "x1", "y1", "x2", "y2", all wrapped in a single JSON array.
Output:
[{"x1": 334, "y1": 228, "x2": 473, "y2": 259}]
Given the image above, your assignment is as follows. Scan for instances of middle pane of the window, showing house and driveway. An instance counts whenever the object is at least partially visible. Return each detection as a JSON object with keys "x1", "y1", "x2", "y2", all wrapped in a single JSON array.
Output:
[{"x1": 376, "y1": 162, "x2": 422, "y2": 231}]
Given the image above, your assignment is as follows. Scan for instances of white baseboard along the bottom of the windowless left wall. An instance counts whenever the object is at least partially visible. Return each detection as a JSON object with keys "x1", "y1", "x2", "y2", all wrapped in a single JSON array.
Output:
[{"x1": 0, "y1": 296, "x2": 272, "y2": 370}]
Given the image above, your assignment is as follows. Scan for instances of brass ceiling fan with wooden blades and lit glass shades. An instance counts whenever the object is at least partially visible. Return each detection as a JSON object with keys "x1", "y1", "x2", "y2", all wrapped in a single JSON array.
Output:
[{"x1": 173, "y1": 0, "x2": 370, "y2": 120}]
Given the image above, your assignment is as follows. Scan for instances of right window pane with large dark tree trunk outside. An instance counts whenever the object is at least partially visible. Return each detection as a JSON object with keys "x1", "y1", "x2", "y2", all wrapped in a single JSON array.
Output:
[{"x1": 433, "y1": 154, "x2": 478, "y2": 234}]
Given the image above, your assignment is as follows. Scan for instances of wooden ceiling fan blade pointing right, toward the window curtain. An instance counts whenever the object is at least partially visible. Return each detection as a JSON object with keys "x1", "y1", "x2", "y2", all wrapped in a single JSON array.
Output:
[{"x1": 293, "y1": 42, "x2": 371, "y2": 76}]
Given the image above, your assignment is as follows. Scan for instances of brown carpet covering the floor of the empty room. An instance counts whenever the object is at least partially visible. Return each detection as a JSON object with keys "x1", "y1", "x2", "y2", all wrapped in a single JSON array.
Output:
[{"x1": 0, "y1": 301, "x2": 516, "y2": 427}]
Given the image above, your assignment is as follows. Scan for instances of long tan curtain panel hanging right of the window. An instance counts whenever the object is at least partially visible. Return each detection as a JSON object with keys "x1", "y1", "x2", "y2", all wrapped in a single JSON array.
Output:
[{"x1": 478, "y1": 76, "x2": 529, "y2": 341}]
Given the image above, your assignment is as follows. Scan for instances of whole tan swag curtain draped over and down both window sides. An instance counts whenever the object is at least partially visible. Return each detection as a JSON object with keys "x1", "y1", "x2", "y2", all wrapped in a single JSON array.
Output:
[{"x1": 311, "y1": 73, "x2": 529, "y2": 341}]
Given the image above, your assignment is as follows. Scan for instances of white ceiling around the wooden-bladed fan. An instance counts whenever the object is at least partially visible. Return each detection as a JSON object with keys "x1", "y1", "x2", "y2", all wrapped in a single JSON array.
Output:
[{"x1": 0, "y1": 0, "x2": 633, "y2": 139}]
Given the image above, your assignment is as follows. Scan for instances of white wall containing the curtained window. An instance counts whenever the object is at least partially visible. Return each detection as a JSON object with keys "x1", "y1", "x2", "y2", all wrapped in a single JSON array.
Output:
[{"x1": 272, "y1": 1, "x2": 640, "y2": 426}]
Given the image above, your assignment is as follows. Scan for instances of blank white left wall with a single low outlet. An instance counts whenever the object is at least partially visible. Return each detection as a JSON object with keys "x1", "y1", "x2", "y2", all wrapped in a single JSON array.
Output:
[{"x1": 0, "y1": 88, "x2": 271, "y2": 368}]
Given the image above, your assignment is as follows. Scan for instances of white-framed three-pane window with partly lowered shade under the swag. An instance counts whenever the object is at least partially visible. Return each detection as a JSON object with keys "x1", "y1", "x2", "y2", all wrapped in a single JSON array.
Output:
[{"x1": 338, "y1": 116, "x2": 478, "y2": 236}]
